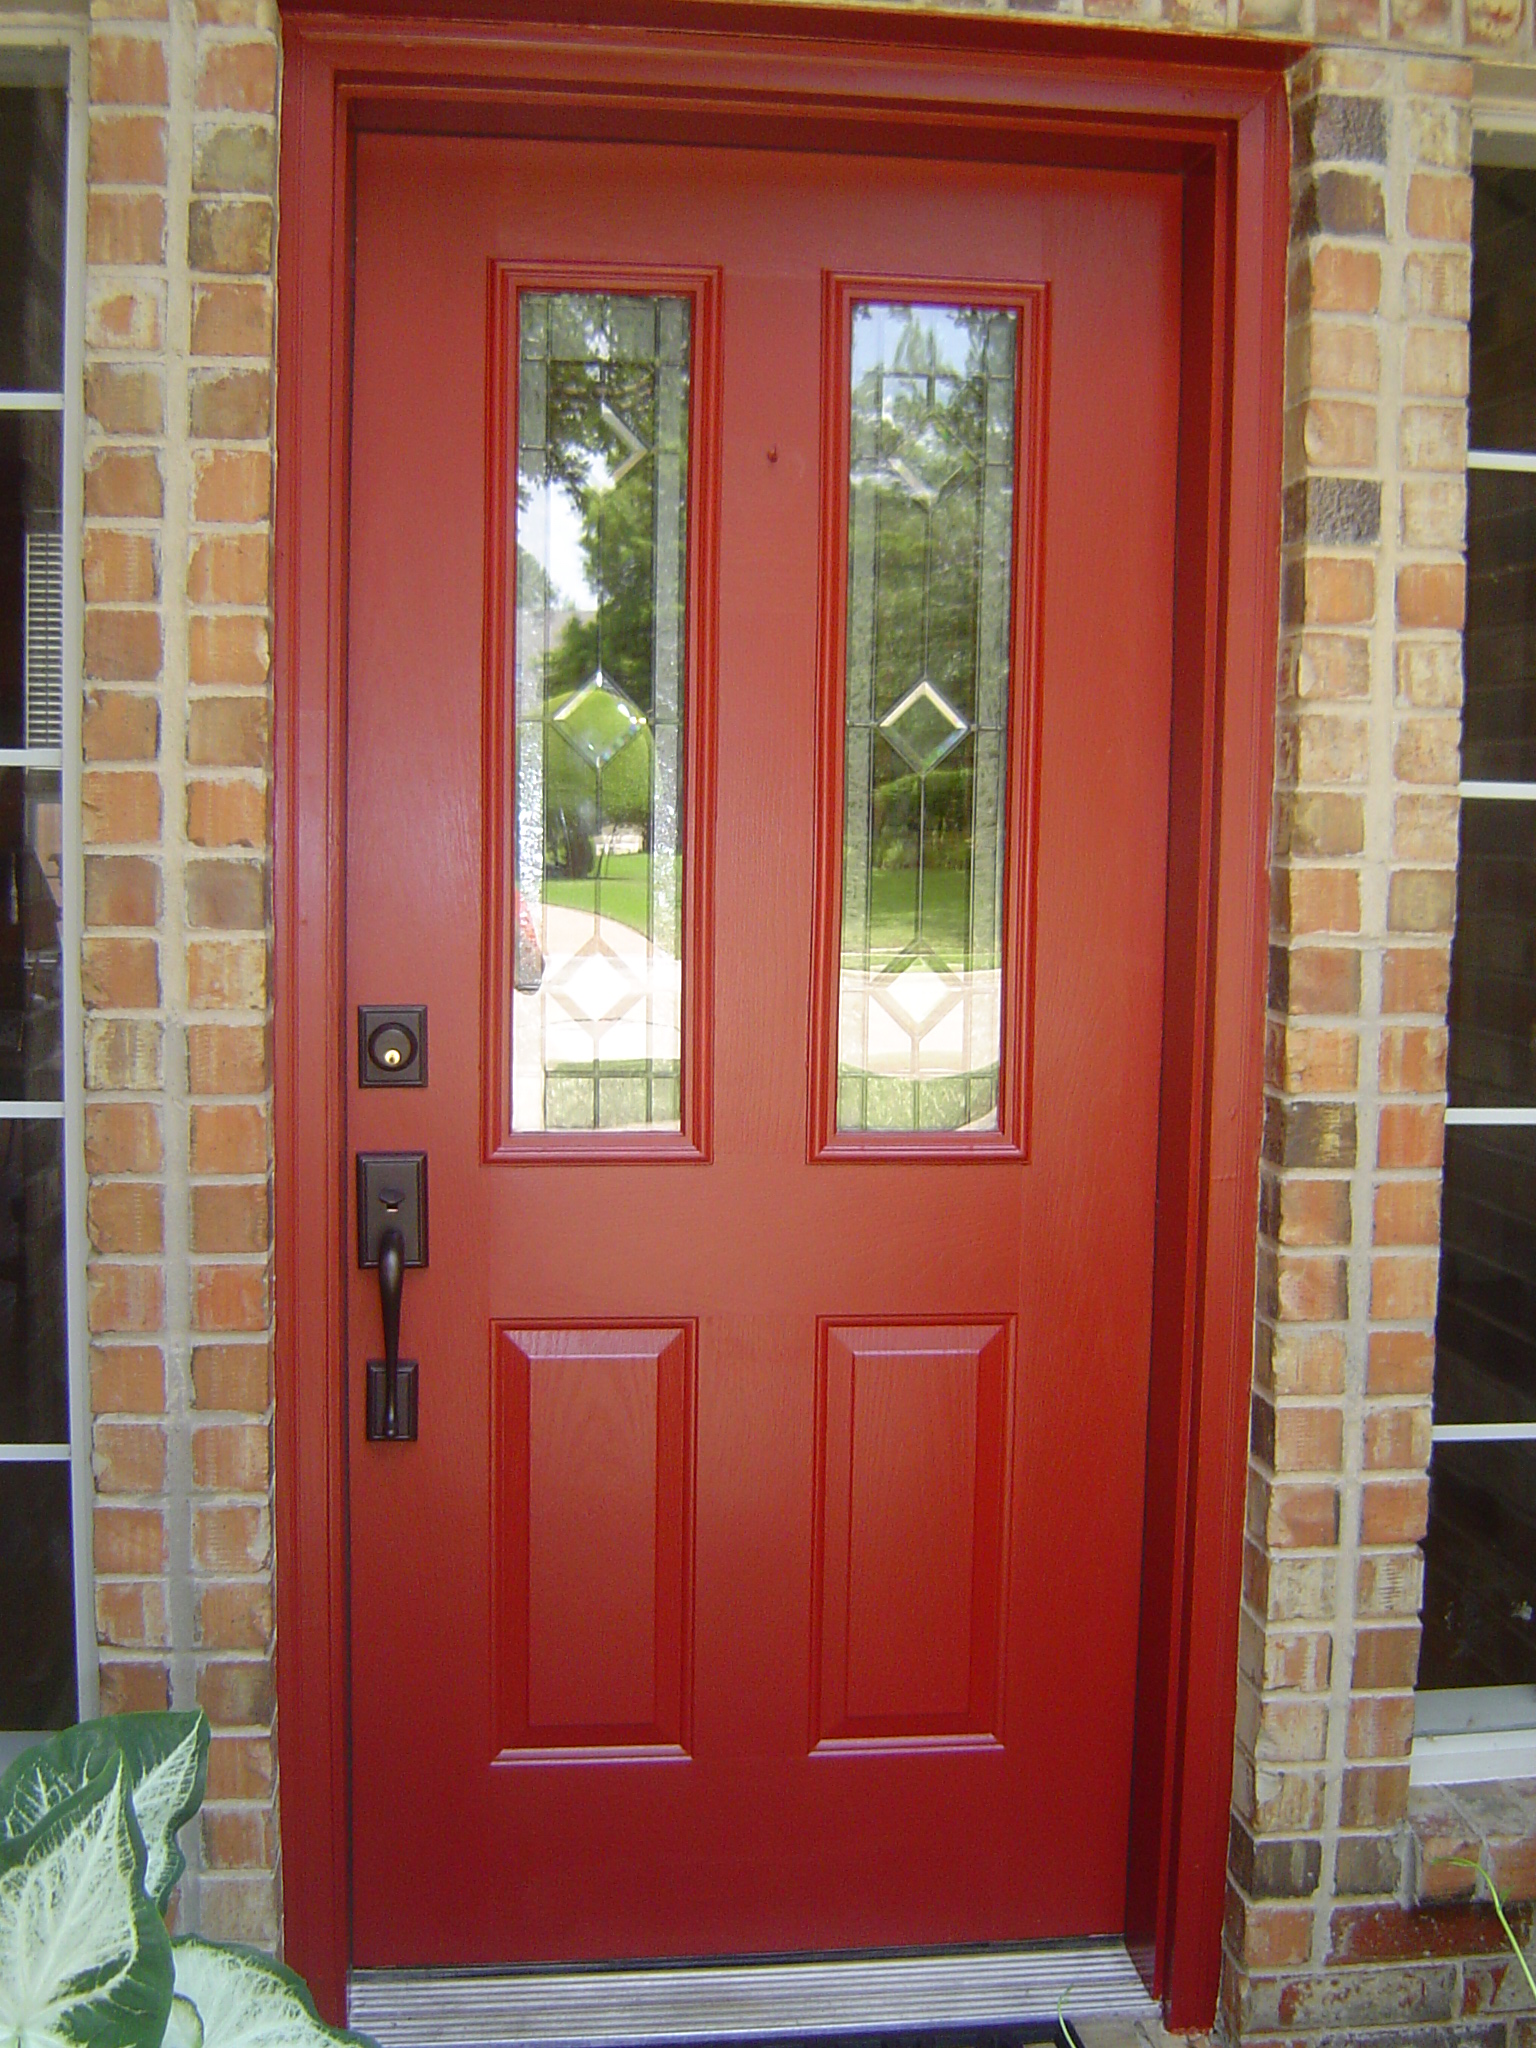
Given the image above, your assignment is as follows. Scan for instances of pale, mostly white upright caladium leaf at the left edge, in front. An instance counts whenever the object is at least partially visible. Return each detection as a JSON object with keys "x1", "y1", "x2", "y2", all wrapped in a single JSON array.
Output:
[{"x1": 0, "y1": 1755, "x2": 172, "y2": 2048}]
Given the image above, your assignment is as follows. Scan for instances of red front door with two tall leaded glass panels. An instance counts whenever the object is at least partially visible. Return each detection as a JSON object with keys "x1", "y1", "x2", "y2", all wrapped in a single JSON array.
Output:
[{"x1": 346, "y1": 135, "x2": 1180, "y2": 1966}]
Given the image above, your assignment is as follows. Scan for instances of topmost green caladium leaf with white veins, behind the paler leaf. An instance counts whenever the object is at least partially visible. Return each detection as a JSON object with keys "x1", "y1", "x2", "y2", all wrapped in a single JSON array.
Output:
[{"x1": 0, "y1": 1712, "x2": 209, "y2": 1908}]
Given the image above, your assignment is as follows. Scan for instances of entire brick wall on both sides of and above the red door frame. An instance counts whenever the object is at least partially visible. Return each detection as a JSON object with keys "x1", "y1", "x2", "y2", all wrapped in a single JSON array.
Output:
[{"x1": 54, "y1": 0, "x2": 1536, "y2": 2015}]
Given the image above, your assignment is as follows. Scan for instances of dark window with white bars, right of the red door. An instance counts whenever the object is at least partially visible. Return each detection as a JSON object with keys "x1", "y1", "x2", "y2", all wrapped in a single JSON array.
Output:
[{"x1": 1413, "y1": 133, "x2": 1536, "y2": 1784}]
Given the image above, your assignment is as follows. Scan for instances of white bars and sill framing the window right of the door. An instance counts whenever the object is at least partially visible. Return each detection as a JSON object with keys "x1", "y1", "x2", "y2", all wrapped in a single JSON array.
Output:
[{"x1": 1409, "y1": 103, "x2": 1536, "y2": 1786}]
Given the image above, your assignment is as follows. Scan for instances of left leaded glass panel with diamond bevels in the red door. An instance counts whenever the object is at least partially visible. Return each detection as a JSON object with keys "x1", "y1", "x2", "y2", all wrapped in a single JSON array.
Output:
[{"x1": 512, "y1": 291, "x2": 690, "y2": 1130}]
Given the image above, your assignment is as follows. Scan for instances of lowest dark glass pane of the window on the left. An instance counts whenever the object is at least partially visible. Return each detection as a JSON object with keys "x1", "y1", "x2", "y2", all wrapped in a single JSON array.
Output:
[{"x1": 0, "y1": 1464, "x2": 76, "y2": 1731}]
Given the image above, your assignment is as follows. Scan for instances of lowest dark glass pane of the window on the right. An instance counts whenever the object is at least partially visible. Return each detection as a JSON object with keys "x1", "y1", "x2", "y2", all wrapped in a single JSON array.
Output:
[{"x1": 1419, "y1": 1444, "x2": 1536, "y2": 1690}]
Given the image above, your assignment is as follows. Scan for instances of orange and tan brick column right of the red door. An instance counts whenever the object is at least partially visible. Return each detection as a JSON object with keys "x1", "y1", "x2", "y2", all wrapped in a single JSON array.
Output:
[{"x1": 1223, "y1": 51, "x2": 1483, "y2": 2040}]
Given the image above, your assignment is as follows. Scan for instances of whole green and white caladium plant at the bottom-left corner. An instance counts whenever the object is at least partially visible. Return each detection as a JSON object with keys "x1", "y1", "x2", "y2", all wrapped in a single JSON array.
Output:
[{"x1": 0, "y1": 1712, "x2": 371, "y2": 2048}]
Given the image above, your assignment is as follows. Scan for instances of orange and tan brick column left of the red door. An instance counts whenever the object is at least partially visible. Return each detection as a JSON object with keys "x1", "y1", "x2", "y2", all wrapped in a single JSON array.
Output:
[{"x1": 82, "y1": 0, "x2": 279, "y2": 1944}]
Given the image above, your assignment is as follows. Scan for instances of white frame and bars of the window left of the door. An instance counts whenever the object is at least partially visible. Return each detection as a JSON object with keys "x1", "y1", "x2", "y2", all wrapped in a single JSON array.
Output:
[{"x1": 0, "y1": 12, "x2": 100, "y2": 1767}]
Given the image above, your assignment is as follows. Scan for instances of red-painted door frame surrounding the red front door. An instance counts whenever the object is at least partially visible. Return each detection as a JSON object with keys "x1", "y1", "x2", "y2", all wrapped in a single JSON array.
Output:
[{"x1": 274, "y1": 0, "x2": 1300, "y2": 2028}]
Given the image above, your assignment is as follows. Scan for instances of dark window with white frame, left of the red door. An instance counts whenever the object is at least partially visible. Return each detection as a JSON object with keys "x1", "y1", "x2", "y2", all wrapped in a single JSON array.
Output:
[{"x1": 0, "y1": 31, "x2": 94, "y2": 1765}]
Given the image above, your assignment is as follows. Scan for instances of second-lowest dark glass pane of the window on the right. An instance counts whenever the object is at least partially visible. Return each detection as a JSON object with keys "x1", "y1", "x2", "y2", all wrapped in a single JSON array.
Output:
[{"x1": 1436, "y1": 1124, "x2": 1536, "y2": 1421}]
